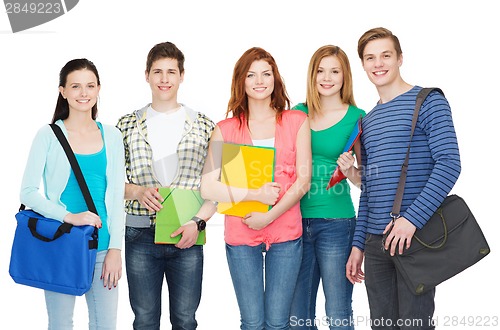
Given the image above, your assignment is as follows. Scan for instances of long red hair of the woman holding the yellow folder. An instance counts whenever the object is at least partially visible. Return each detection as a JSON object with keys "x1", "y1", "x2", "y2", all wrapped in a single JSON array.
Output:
[{"x1": 226, "y1": 47, "x2": 290, "y2": 124}]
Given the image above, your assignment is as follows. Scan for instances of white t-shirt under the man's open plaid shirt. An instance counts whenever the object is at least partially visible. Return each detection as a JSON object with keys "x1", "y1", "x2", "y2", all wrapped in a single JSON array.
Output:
[{"x1": 146, "y1": 106, "x2": 186, "y2": 187}]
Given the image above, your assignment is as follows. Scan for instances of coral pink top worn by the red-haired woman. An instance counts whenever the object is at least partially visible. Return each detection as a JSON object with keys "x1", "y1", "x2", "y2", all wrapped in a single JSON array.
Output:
[{"x1": 217, "y1": 110, "x2": 307, "y2": 249}]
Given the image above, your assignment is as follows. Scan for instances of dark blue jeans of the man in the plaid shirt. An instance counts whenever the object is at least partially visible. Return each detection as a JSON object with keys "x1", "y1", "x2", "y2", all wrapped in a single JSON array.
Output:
[{"x1": 125, "y1": 226, "x2": 203, "y2": 330}]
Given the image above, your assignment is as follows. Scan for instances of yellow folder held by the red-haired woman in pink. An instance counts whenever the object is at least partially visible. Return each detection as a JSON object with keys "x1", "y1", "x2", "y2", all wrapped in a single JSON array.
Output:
[{"x1": 217, "y1": 143, "x2": 276, "y2": 217}]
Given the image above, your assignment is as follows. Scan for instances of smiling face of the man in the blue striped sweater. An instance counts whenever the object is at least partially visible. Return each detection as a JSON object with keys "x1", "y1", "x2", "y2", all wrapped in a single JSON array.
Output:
[{"x1": 362, "y1": 38, "x2": 403, "y2": 88}]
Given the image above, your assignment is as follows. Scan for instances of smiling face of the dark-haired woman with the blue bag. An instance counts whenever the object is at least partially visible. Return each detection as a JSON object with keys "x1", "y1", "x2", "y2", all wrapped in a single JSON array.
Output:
[{"x1": 59, "y1": 69, "x2": 101, "y2": 112}]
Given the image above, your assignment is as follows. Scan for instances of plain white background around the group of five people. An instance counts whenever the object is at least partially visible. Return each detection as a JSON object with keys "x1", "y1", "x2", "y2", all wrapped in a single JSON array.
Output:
[{"x1": 0, "y1": 0, "x2": 500, "y2": 330}]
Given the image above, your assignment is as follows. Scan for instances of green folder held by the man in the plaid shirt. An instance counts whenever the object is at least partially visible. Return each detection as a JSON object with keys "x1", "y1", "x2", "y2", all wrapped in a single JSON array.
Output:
[{"x1": 155, "y1": 187, "x2": 206, "y2": 245}]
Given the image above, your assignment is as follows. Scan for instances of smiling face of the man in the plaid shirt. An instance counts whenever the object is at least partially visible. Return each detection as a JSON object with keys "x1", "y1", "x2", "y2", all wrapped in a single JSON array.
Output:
[{"x1": 146, "y1": 58, "x2": 184, "y2": 103}]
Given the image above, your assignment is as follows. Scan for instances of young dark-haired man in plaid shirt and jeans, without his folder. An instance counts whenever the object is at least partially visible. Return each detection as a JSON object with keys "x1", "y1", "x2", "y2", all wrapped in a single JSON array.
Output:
[{"x1": 117, "y1": 42, "x2": 216, "y2": 330}]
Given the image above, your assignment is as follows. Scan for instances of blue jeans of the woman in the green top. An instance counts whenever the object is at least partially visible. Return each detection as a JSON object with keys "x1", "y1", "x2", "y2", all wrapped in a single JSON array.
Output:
[{"x1": 290, "y1": 218, "x2": 356, "y2": 330}]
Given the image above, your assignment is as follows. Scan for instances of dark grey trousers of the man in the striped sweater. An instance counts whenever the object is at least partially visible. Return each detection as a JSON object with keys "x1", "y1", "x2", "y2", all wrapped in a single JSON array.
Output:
[{"x1": 365, "y1": 234, "x2": 435, "y2": 330}]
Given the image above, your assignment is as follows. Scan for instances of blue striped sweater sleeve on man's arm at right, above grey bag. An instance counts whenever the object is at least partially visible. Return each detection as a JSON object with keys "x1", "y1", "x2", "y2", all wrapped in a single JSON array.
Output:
[{"x1": 402, "y1": 91, "x2": 461, "y2": 229}]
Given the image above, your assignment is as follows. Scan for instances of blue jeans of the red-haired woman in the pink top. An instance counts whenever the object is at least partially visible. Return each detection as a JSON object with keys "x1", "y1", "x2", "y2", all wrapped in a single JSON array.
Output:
[{"x1": 226, "y1": 238, "x2": 302, "y2": 330}]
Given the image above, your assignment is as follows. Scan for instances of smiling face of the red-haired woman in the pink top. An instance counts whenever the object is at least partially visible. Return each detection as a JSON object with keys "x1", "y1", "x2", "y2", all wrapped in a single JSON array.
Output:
[{"x1": 245, "y1": 60, "x2": 274, "y2": 100}]
